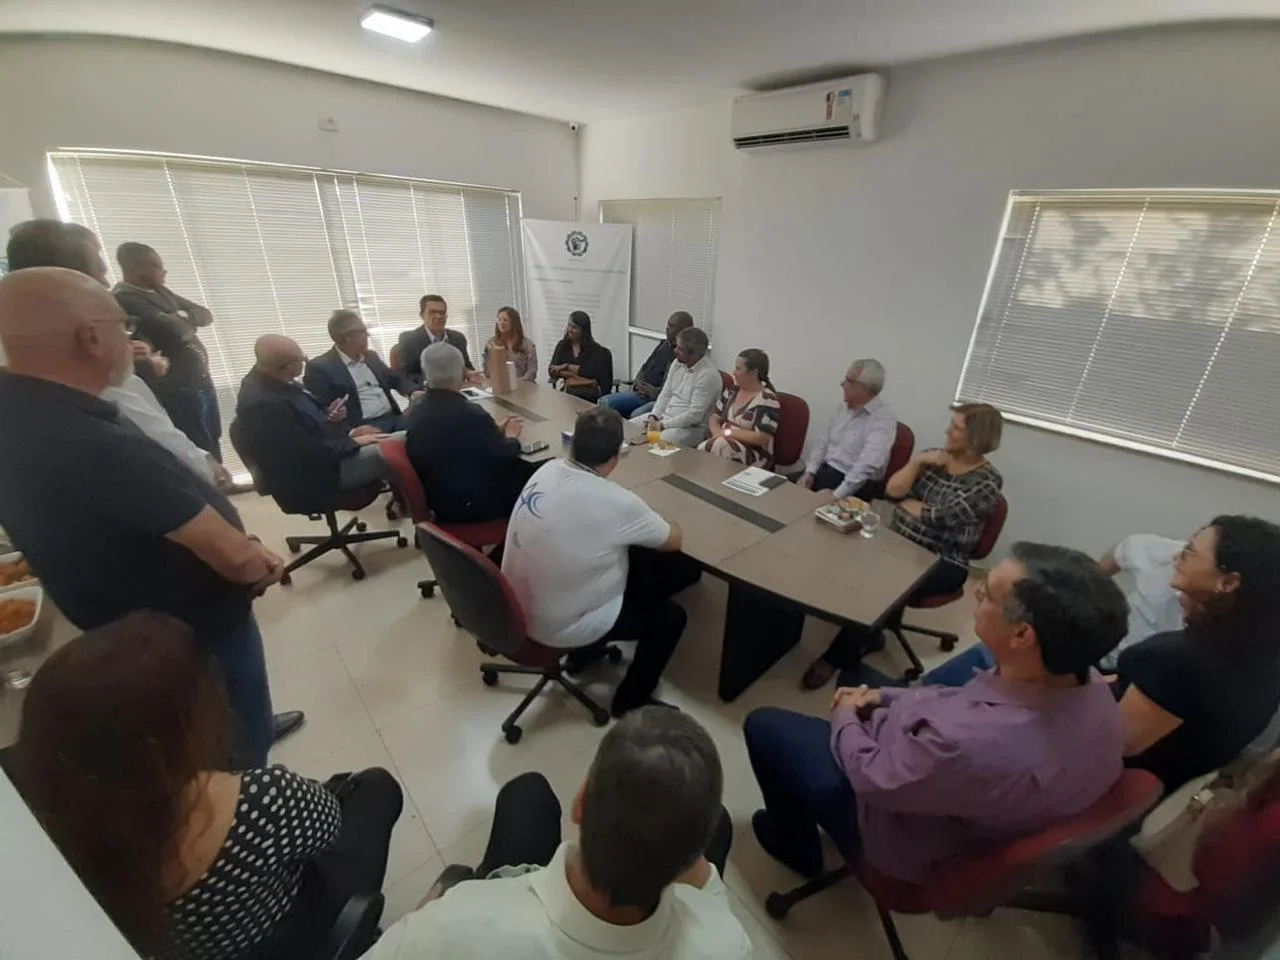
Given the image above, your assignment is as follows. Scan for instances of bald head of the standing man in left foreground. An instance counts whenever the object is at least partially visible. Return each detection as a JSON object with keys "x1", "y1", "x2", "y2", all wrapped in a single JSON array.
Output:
[{"x1": 0, "y1": 266, "x2": 133, "y2": 394}]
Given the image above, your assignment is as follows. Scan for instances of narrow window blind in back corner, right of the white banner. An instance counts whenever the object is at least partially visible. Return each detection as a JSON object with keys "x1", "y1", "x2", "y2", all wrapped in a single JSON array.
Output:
[{"x1": 600, "y1": 198, "x2": 721, "y2": 334}]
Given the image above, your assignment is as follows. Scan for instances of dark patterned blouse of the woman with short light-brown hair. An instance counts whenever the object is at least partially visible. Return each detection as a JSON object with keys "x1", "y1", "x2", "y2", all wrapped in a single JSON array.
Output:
[{"x1": 892, "y1": 463, "x2": 1005, "y2": 566}]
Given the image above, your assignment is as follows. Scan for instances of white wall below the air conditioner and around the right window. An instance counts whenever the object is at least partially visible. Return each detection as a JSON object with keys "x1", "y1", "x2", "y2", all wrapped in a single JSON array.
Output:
[{"x1": 581, "y1": 26, "x2": 1280, "y2": 552}]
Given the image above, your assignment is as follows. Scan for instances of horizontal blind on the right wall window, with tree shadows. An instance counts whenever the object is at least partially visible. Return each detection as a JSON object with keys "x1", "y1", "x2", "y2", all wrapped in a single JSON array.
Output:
[{"x1": 956, "y1": 191, "x2": 1280, "y2": 481}]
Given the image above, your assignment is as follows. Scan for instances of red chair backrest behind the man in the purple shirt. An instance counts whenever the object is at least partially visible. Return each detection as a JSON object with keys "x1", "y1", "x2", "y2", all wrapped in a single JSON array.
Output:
[{"x1": 921, "y1": 769, "x2": 1164, "y2": 916}]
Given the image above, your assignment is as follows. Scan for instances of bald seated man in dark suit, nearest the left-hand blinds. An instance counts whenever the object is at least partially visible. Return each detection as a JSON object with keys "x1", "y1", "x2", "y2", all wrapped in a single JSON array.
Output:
[{"x1": 236, "y1": 334, "x2": 393, "y2": 508}]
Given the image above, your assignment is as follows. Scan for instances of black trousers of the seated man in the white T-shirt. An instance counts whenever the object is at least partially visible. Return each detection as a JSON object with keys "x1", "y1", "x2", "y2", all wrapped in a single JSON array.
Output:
[{"x1": 582, "y1": 547, "x2": 701, "y2": 713}]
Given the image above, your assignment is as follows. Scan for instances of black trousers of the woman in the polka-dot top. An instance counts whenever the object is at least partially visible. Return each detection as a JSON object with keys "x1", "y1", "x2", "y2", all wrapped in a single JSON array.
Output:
[{"x1": 246, "y1": 767, "x2": 404, "y2": 960}]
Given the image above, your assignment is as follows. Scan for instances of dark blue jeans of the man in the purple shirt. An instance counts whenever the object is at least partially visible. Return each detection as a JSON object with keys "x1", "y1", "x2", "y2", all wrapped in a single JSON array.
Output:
[{"x1": 742, "y1": 707, "x2": 861, "y2": 876}]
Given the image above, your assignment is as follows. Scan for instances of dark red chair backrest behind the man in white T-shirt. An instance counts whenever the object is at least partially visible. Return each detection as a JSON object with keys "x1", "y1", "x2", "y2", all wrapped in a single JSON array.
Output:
[{"x1": 417, "y1": 524, "x2": 529, "y2": 655}]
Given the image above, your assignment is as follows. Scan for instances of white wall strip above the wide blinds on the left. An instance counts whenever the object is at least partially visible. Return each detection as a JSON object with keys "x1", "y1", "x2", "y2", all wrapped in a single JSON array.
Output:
[{"x1": 0, "y1": 37, "x2": 577, "y2": 219}]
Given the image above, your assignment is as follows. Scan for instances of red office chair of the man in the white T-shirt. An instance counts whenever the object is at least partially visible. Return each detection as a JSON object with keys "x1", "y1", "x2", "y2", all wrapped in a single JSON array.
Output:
[{"x1": 417, "y1": 524, "x2": 622, "y2": 744}]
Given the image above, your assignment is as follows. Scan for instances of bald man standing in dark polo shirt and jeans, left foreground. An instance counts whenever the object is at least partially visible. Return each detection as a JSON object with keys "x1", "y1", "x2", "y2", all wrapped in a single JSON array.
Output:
[{"x1": 0, "y1": 268, "x2": 288, "y2": 765}]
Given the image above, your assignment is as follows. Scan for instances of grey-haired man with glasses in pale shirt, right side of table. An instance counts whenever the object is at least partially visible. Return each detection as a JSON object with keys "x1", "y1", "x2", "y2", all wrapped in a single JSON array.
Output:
[{"x1": 800, "y1": 358, "x2": 897, "y2": 500}]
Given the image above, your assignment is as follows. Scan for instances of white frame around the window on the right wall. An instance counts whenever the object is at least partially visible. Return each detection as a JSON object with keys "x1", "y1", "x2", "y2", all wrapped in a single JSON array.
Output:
[{"x1": 952, "y1": 187, "x2": 1280, "y2": 486}]
